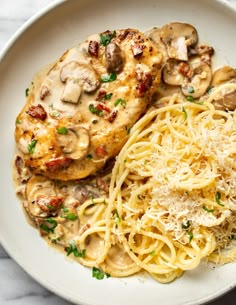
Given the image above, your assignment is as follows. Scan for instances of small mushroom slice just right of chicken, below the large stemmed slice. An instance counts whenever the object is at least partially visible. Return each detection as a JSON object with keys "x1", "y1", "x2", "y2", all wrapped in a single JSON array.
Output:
[{"x1": 162, "y1": 59, "x2": 185, "y2": 86}]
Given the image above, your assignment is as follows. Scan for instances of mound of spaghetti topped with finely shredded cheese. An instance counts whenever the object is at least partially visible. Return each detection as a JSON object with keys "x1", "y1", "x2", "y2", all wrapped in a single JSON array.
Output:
[{"x1": 77, "y1": 91, "x2": 236, "y2": 283}]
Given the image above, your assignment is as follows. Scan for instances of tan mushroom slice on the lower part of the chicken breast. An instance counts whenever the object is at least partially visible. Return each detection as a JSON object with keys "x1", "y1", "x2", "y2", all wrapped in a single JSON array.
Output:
[{"x1": 56, "y1": 125, "x2": 90, "y2": 160}]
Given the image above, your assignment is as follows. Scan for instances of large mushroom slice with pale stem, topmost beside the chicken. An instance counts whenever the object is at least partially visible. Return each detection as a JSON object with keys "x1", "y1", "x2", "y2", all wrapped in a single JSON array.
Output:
[{"x1": 160, "y1": 22, "x2": 198, "y2": 61}]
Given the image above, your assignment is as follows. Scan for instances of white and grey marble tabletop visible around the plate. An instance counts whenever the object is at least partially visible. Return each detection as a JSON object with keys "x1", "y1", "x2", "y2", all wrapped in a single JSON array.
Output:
[{"x1": 0, "y1": 0, "x2": 236, "y2": 305}]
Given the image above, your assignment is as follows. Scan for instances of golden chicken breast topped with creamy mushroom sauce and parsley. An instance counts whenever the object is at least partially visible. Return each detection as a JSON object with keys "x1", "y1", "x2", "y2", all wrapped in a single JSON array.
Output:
[{"x1": 15, "y1": 29, "x2": 162, "y2": 180}]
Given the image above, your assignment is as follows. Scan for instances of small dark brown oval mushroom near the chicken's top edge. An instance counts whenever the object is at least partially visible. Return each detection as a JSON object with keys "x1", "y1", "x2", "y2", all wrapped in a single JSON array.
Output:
[{"x1": 105, "y1": 42, "x2": 124, "y2": 73}]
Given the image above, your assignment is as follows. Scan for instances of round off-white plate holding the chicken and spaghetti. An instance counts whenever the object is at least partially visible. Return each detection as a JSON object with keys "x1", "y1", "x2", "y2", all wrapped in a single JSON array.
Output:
[{"x1": 0, "y1": 0, "x2": 236, "y2": 305}]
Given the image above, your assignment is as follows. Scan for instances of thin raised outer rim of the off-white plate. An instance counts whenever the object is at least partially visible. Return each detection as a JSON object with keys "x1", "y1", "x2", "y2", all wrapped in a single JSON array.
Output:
[{"x1": 0, "y1": 0, "x2": 236, "y2": 305}]
